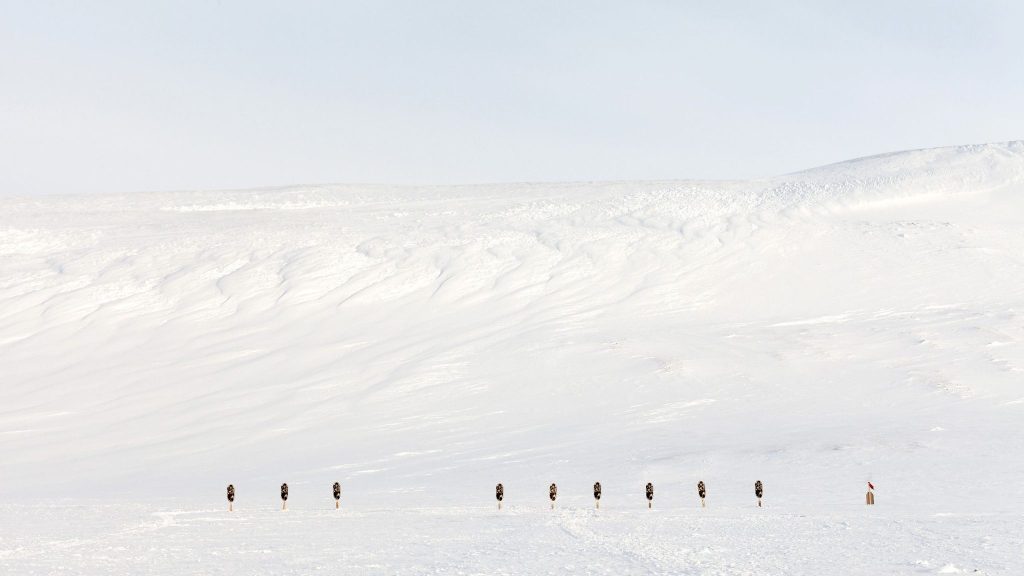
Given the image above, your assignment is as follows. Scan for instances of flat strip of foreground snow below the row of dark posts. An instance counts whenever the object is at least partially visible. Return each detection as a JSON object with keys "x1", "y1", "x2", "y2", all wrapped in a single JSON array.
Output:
[{"x1": 0, "y1": 504, "x2": 1022, "y2": 575}]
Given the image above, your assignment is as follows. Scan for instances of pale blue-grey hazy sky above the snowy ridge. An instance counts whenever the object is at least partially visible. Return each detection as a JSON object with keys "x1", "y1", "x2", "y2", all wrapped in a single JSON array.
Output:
[{"x1": 0, "y1": 0, "x2": 1024, "y2": 196}]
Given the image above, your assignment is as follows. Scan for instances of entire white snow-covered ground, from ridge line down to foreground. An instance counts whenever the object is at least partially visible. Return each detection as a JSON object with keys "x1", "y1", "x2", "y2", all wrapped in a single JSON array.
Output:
[{"x1": 0, "y1": 141, "x2": 1024, "y2": 574}]
